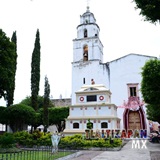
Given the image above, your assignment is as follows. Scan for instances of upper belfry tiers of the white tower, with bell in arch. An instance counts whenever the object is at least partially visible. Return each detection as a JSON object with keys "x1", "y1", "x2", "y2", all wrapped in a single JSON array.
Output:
[{"x1": 73, "y1": 7, "x2": 103, "y2": 62}]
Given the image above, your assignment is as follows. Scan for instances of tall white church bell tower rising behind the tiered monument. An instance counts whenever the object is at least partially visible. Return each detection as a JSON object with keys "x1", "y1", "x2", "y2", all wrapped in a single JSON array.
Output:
[{"x1": 72, "y1": 7, "x2": 110, "y2": 105}]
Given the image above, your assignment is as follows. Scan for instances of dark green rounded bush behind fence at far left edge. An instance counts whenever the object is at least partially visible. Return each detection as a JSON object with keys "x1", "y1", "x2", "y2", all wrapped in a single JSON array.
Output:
[{"x1": 0, "y1": 133, "x2": 15, "y2": 148}]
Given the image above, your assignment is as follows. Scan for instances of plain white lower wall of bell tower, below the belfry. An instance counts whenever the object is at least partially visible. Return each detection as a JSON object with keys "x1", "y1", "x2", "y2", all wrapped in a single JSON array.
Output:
[{"x1": 72, "y1": 61, "x2": 109, "y2": 105}]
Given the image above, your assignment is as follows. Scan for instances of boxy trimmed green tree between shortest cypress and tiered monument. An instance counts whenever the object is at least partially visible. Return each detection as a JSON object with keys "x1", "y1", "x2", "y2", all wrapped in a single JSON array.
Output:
[{"x1": 49, "y1": 107, "x2": 69, "y2": 132}]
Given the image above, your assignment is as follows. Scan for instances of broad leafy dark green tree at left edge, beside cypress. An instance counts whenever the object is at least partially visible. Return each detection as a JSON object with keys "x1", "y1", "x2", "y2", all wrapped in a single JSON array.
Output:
[{"x1": 0, "y1": 29, "x2": 17, "y2": 101}]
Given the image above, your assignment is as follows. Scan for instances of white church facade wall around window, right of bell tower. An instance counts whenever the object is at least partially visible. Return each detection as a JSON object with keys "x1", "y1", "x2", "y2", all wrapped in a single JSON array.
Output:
[{"x1": 109, "y1": 54, "x2": 154, "y2": 128}]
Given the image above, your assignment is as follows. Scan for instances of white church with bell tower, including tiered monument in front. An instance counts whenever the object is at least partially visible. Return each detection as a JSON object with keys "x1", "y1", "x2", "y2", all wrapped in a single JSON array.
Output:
[{"x1": 64, "y1": 7, "x2": 157, "y2": 134}]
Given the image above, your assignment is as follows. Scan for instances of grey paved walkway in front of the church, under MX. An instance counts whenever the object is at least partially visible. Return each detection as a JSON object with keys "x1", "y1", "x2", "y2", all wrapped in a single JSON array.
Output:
[{"x1": 71, "y1": 141, "x2": 160, "y2": 160}]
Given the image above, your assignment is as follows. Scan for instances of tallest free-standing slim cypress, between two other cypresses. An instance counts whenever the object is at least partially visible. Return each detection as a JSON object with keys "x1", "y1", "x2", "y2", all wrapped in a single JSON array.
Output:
[{"x1": 31, "y1": 29, "x2": 41, "y2": 111}]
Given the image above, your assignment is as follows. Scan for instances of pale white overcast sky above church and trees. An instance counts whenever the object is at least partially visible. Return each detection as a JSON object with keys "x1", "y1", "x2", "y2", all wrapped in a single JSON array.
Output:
[{"x1": 0, "y1": 0, "x2": 160, "y2": 105}]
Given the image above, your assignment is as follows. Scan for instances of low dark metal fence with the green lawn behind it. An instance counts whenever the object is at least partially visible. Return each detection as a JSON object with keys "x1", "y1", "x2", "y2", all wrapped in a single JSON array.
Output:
[{"x1": 0, "y1": 147, "x2": 73, "y2": 160}]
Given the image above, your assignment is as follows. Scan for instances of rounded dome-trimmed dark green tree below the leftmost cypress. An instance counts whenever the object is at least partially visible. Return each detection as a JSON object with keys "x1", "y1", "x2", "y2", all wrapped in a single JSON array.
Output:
[{"x1": 6, "y1": 104, "x2": 36, "y2": 132}]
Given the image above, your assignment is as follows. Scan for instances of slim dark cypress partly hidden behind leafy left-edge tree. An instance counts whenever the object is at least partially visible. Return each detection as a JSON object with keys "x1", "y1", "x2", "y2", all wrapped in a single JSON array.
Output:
[{"x1": 7, "y1": 31, "x2": 17, "y2": 106}]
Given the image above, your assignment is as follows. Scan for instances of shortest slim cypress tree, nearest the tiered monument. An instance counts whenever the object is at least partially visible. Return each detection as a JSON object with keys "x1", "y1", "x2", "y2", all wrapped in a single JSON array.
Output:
[{"x1": 43, "y1": 76, "x2": 50, "y2": 132}]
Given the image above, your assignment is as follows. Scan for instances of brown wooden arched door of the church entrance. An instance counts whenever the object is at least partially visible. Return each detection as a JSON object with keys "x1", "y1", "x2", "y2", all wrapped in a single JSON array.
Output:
[{"x1": 128, "y1": 111, "x2": 141, "y2": 130}]
